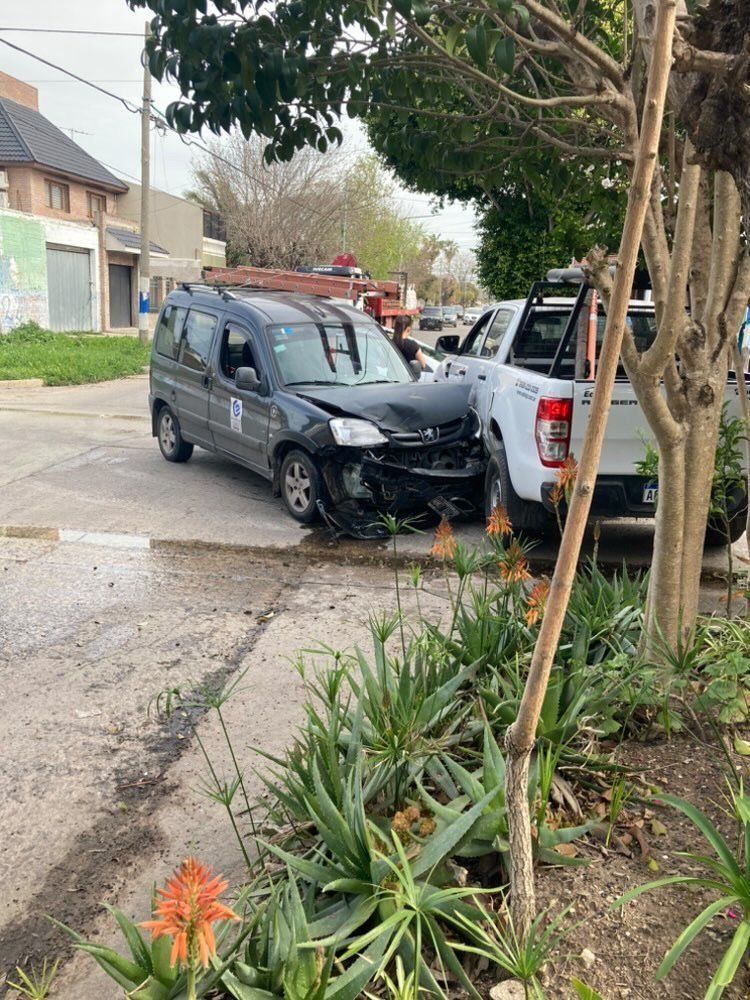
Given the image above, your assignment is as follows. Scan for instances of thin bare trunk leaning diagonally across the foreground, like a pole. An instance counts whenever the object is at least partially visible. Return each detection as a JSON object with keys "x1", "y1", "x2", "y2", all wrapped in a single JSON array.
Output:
[{"x1": 506, "y1": 0, "x2": 676, "y2": 938}]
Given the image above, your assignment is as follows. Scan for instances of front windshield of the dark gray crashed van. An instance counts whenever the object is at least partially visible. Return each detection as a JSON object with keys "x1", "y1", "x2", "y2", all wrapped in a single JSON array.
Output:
[{"x1": 267, "y1": 323, "x2": 413, "y2": 386}]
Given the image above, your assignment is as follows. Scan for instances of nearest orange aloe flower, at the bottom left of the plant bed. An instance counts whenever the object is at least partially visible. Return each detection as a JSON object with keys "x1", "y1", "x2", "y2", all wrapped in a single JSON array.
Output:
[{"x1": 141, "y1": 858, "x2": 240, "y2": 969}]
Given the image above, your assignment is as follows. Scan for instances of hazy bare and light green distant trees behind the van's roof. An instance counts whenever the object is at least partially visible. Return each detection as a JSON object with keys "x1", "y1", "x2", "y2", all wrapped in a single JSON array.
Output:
[{"x1": 190, "y1": 132, "x2": 436, "y2": 282}]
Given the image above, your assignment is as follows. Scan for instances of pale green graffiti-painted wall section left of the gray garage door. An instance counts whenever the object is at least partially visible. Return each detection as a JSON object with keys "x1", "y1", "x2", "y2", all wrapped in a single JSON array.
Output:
[{"x1": 0, "y1": 212, "x2": 49, "y2": 333}]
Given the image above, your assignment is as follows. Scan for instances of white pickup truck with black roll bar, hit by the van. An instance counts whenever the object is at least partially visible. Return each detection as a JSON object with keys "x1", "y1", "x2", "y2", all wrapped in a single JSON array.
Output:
[{"x1": 434, "y1": 282, "x2": 747, "y2": 543}]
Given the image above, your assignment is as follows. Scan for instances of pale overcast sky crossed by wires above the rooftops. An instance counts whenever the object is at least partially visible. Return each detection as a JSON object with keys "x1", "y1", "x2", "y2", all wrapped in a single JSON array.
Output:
[{"x1": 0, "y1": 0, "x2": 475, "y2": 258}]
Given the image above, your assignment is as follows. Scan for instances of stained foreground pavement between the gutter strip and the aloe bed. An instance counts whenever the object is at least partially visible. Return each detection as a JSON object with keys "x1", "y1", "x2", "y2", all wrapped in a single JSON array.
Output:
[{"x1": 0, "y1": 536, "x2": 448, "y2": 1000}]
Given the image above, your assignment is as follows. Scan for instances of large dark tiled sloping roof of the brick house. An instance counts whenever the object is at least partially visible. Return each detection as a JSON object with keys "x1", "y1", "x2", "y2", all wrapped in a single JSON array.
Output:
[{"x1": 0, "y1": 97, "x2": 128, "y2": 191}]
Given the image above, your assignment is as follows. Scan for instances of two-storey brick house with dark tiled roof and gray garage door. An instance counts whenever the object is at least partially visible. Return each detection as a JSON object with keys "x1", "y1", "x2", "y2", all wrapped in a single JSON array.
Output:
[{"x1": 0, "y1": 72, "x2": 169, "y2": 331}]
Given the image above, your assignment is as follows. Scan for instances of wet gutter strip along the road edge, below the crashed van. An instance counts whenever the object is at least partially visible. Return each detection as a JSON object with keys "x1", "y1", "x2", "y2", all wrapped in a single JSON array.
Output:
[{"x1": 0, "y1": 525, "x2": 726, "y2": 583}]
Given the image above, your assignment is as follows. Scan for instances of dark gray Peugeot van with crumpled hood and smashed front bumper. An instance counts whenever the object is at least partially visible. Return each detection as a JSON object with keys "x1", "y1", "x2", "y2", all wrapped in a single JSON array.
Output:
[{"x1": 149, "y1": 285, "x2": 484, "y2": 522}]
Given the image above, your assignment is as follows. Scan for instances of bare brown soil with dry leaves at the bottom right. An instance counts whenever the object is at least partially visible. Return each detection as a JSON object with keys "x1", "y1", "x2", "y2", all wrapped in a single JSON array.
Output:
[{"x1": 538, "y1": 736, "x2": 750, "y2": 1000}]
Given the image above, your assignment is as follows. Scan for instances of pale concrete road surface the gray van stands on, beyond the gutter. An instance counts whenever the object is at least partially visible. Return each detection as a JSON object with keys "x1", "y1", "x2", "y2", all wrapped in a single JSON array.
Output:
[{"x1": 0, "y1": 376, "x2": 748, "y2": 577}]
